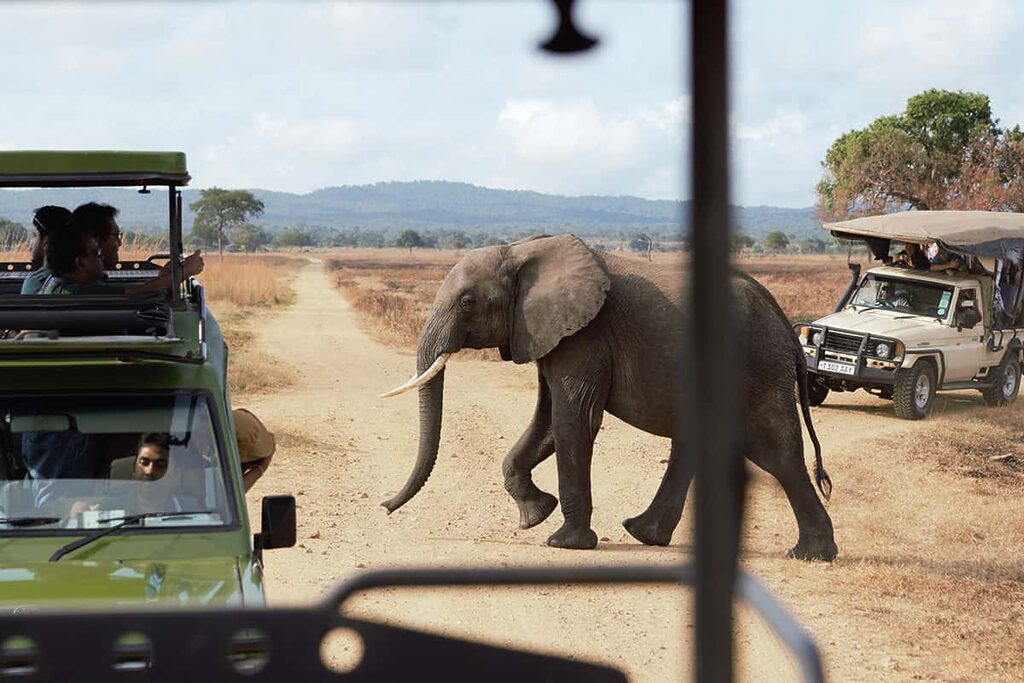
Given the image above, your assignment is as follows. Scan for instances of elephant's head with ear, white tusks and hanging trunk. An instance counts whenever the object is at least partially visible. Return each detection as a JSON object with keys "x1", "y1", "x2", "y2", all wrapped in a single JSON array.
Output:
[{"x1": 382, "y1": 234, "x2": 611, "y2": 514}]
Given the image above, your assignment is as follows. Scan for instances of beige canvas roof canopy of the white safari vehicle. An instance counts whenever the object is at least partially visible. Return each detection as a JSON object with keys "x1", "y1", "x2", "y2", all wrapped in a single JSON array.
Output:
[{"x1": 824, "y1": 211, "x2": 1024, "y2": 258}]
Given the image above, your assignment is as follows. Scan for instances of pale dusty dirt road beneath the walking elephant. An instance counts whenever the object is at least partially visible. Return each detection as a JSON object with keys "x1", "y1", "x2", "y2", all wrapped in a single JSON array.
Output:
[{"x1": 243, "y1": 262, "x2": 1019, "y2": 681}]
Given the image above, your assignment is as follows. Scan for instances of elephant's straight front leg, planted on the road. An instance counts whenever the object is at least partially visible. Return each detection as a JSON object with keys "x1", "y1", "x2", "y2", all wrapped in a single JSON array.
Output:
[{"x1": 548, "y1": 378, "x2": 604, "y2": 550}]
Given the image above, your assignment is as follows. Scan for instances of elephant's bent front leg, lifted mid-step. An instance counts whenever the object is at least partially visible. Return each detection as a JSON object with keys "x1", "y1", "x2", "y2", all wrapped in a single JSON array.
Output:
[{"x1": 502, "y1": 378, "x2": 558, "y2": 528}]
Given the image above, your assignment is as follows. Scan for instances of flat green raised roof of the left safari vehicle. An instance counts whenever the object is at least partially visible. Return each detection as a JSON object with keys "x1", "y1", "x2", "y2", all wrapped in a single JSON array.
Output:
[{"x1": 0, "y1": 151, "x2": 190, "y2": 187}]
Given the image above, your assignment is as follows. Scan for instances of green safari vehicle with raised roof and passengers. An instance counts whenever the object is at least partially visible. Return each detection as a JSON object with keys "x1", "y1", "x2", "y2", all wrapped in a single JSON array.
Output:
[{"x1": 0, "y1": 152, "x2": 295, "y2": 611}]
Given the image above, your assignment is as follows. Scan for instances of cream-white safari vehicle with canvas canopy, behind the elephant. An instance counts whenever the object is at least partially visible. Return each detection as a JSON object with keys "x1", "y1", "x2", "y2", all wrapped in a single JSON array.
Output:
[{"x1": 796, "y1": 211, "x2": 1024, "y2": 420}]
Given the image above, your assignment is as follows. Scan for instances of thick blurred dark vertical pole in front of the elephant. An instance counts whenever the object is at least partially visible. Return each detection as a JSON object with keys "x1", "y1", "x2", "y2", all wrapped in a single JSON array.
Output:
[{"x1": 678, "y1": 0, "x2": 744, "y2": 682}]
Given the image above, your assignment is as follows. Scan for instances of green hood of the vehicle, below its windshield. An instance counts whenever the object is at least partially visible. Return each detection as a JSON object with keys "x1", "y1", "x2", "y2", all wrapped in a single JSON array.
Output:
[{"x1": 0, "y1": 557, "x2": 243, "y2": 613}]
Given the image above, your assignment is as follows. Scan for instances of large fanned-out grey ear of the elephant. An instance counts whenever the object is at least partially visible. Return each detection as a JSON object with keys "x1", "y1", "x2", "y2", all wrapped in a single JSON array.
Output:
[{"x1": 509, "y1": 234, "x2": 611, "y2": 364}]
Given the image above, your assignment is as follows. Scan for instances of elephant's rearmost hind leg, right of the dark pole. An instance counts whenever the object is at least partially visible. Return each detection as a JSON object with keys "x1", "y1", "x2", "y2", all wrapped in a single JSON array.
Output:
[{"x1": 750, "y1": 396, "x2": 839, "y2": 561}]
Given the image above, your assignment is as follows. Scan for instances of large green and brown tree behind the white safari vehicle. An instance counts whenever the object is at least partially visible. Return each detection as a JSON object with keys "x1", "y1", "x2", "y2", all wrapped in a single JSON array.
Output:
[{"x1": 817, "y1": 90, "x2": 1024, "y2": 220}]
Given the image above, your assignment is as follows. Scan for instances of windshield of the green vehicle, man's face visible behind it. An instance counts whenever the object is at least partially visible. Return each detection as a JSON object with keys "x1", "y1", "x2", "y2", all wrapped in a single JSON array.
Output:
[{"x1": 0, "y1": 394, "x2": 231, "y2": 535}]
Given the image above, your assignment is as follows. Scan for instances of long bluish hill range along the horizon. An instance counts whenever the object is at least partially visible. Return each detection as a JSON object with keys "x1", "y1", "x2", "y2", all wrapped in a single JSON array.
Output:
[{"x1": 0, "y1": 180, "x2": 820, "y2": 240}]
